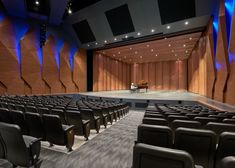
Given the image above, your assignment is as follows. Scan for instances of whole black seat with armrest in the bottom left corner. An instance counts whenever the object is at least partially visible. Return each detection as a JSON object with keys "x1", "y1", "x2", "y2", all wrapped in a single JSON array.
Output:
[{"x1": 0, "y1": 123, "x2": 42, "y2": 168}]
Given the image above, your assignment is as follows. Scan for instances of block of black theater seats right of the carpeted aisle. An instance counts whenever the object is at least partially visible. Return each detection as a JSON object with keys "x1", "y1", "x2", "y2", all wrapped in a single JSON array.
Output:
[{"x1": 133, "y1": 105, "x2": 235, "y2": 168}]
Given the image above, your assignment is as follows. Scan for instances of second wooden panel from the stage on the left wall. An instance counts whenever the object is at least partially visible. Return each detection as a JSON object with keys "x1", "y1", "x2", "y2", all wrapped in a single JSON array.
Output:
[{"x1": 60, "y1": 43, "x2": 76, "y2": 93}]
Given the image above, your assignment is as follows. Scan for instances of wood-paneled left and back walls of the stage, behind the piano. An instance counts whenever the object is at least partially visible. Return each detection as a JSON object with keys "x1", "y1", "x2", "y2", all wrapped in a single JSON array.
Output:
[{"x1": 93, "y1": 53, "x2": 187, "y2": 91}]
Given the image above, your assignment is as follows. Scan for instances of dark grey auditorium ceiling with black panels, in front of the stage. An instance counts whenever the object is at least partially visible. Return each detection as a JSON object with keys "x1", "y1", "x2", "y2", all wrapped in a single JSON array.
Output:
[{"x1": 0, "y1": 0, "x2": 219, "y2": 49}]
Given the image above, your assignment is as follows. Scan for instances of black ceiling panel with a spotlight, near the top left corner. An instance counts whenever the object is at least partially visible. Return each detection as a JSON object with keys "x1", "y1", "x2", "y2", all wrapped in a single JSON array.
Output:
[{"x1": 26, "y1": 0, "x2": 50, "y2": 16}]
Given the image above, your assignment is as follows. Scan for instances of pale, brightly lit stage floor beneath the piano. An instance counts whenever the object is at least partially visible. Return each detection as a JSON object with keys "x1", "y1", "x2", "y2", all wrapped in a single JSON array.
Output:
[{"x1": 80, "y1": 89, "x2": 235, "y2": 111}]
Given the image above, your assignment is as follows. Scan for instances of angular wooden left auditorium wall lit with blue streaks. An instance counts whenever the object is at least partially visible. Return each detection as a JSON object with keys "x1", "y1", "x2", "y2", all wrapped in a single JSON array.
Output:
[{"x1": 0, "y1": 13, "x2": 87, "y2": 95}]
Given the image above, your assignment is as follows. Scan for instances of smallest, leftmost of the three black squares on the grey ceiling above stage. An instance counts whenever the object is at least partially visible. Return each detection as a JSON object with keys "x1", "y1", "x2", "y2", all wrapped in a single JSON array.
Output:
[{"x1": 73, "y1": 20, "x2": 96, "y2": 43}]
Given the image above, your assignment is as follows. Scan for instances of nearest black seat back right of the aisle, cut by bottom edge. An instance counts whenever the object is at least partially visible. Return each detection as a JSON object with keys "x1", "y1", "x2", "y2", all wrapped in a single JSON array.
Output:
[{"x1": 132, "y1": 143, "x2": 194, "y2": 168}]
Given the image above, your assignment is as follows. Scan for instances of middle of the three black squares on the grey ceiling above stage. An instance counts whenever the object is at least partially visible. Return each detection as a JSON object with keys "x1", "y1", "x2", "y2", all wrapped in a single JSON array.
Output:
[{"x1": 105, "y1": 4, "x2": 135, "y2": 36}]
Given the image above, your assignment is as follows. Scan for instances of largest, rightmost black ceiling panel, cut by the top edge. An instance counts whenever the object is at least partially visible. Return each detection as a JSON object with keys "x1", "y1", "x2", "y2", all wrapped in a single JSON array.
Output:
[{"x1": 158, "y1": 0, "x2": 196, "y2": 24}]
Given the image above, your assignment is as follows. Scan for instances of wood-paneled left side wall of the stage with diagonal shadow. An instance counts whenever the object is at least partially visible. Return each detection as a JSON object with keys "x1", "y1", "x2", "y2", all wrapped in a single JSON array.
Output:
[{"x1": 93, "y1": 53, "x2": 131, "y2": 91}]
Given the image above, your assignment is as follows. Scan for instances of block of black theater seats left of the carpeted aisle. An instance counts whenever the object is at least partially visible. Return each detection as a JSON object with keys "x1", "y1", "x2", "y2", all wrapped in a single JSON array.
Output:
[{"x1": 0, "y1": 96, "x2": 129, "y2": 166}]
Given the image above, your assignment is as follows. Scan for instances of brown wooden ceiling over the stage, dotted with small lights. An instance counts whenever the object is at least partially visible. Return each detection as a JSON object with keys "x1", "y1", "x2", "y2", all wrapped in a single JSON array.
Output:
[{"x1": 97, "y1": 32, "x2": 201, "y2": 64}]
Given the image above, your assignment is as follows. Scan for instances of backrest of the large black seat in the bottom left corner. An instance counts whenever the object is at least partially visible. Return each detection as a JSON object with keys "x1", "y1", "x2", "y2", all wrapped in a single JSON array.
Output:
[{"x1": 0, "y1": 123, "x2": 30, "y2": 165}]
